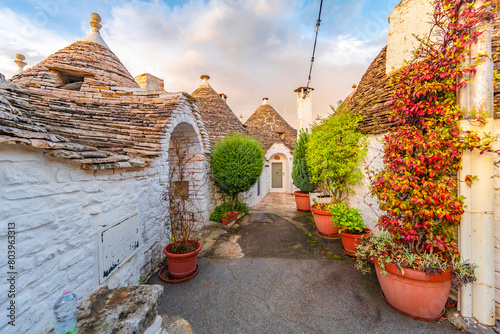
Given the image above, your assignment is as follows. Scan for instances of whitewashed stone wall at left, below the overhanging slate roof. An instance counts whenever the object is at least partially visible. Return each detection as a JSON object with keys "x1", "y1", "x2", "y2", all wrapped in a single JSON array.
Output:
[{"x1": 0, "y1": 145, "x2": 168, "y2": 333}]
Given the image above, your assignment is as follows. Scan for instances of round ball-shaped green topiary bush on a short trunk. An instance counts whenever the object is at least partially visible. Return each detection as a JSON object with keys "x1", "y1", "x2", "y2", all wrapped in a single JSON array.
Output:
[{"x1": 210, "y1": 134, "x2": 264, "y2": 207}]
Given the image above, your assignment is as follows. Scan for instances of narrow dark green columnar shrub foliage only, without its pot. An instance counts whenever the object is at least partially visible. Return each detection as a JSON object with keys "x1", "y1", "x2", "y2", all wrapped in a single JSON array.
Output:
[{"x1": 292, "y1": 130, "x2": 316, "y2": 193}]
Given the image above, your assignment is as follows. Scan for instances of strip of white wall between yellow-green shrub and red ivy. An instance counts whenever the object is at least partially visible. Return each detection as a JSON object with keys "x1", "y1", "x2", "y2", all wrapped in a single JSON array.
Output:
[{"x1": 349, "y1": 135, "x2": 384, "y2": 232}]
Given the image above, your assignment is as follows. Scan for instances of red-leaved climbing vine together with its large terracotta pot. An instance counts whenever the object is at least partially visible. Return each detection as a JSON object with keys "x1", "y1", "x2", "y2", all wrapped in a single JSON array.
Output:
[{"x1": 357, "y1": 0, "x2": 498, "y2": 320}]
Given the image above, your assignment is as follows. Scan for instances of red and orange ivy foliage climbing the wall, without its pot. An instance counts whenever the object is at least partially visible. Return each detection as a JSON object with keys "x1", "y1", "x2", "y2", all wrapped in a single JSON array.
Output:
[{"x1": 371, "y1": 0, "x2": 500, "y2": 256}]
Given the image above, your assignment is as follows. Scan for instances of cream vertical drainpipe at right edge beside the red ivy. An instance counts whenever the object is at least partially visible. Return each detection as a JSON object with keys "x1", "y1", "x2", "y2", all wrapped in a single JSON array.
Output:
[{"x1": 458, "y1": 0, "x2": 495, "y2": 326}]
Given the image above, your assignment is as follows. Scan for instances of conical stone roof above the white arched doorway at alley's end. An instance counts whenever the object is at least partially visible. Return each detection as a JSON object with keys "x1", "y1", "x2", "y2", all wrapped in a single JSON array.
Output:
[{"x1": 245, "y1": 98, "x2": 297, "y2": 151}]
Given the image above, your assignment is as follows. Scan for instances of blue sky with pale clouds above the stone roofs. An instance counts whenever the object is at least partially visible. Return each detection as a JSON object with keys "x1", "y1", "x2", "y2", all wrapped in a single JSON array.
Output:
[{"x1": 0, "y1": 0, "x2": 400, "y2": 127}]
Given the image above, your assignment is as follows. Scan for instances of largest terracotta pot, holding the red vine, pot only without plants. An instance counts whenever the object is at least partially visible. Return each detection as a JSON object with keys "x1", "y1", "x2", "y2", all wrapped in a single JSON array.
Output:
[{"x1": 374, "y1": 261, "x2": 453, "y2": 321}]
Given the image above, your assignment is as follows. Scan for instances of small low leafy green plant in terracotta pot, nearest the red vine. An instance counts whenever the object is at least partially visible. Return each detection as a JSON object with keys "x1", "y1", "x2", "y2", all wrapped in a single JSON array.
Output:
[{"x1": 329, "y1": 203, "x2": 370, "y2": 256}]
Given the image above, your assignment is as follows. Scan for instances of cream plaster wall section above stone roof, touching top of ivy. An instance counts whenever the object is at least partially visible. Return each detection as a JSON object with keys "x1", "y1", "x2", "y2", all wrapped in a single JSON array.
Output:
[{"x1": 386, "y1": 0, "x2": 433, "y2": 75}]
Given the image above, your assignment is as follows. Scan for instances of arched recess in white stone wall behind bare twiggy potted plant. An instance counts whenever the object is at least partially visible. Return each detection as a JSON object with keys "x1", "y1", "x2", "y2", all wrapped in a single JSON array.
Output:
[{"x1": 168, "y1": 122, "x2": 209, "y2": 234}]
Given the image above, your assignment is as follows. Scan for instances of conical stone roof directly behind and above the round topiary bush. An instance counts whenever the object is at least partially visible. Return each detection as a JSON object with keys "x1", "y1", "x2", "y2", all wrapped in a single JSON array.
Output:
[{"x1": 191, "y1": 75, "x2": 248, "y2": 144}]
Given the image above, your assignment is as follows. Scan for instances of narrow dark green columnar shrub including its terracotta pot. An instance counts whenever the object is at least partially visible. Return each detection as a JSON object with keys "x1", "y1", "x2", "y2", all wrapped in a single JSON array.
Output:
[{"x1": 292, "y1": 130, "x2": 316, "y2": 211}]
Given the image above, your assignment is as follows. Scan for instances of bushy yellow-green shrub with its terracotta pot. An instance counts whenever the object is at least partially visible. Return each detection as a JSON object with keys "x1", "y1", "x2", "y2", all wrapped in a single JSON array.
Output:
[{"x1": 306, "y1": 104, "x2": 367, "y2": 237}]
